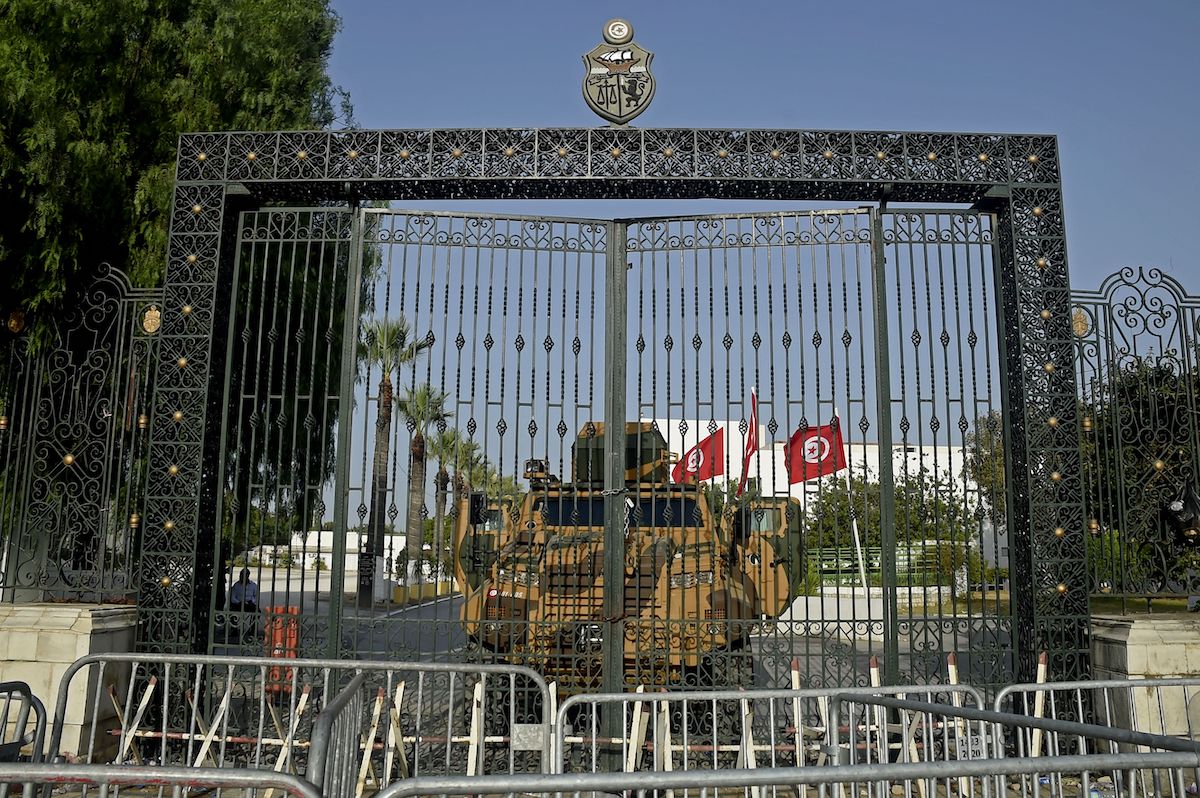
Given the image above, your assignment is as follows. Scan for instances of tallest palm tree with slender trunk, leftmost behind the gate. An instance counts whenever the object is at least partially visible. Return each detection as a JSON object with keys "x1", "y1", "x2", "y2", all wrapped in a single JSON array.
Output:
[{"x1": 359, "y1": 317, "x2": 430, "y2": 606}]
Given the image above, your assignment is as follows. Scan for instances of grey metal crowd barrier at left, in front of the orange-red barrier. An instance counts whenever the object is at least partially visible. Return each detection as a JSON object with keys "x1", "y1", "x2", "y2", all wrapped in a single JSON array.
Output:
[{"x1": 50, "y1": 654, "x2": 550, "y2": 791}]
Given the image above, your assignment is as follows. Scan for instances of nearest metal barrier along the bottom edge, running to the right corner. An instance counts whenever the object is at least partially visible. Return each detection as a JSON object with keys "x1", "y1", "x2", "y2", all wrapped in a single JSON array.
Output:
[{"x1": 376, "y1": 752, "x2": 1200, "y2": 798}]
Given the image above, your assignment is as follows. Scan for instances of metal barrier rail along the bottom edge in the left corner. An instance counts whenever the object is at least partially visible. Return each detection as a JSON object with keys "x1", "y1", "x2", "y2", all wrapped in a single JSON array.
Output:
[{"x1": 0, "y1": 763, "x2": 322, "y2": 798}]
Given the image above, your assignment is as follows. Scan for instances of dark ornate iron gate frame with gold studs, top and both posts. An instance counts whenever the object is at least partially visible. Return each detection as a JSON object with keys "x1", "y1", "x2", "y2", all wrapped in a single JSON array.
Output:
[{"x1": 150, "y1": 127, "x2": 1091, "y2": 679}]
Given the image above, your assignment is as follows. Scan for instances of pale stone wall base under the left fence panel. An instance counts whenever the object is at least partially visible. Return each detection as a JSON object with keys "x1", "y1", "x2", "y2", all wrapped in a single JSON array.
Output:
[{"x1": 0, "y1": 604, "x2": 138, "y2": 762}]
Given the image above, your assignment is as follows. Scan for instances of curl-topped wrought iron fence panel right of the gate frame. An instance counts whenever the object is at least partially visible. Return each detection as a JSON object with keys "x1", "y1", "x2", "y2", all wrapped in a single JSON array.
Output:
[{"x1": 1072, "y1": 268, "x2": 1200, "y2": 610}]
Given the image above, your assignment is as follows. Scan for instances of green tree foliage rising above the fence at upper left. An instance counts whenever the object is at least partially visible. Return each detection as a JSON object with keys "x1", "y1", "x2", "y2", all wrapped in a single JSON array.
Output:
[{"x1": 0, "y1": 0, "x2": 349, "y2": 314}]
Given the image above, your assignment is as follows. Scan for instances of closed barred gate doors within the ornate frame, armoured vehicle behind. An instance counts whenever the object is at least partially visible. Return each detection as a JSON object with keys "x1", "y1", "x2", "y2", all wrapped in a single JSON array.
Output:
[{"x1": 209, "y1": 209, "x2": 1013, "y2": 689}]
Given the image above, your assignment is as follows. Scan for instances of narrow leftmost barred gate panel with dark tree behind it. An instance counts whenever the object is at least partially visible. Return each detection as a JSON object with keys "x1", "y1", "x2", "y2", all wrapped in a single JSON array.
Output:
[{"x1": 208, "y1": 209, "x2": 359, "y2": 656}]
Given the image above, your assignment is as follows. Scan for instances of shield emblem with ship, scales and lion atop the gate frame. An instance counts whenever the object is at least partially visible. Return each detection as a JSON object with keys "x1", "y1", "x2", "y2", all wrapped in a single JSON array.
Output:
[{"x1": 583, "y1": 19, "x2": 654, "y2": 125}]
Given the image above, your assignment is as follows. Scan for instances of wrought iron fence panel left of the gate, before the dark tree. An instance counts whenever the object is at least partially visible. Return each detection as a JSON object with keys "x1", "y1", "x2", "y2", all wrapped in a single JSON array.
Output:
[{"x1": 0, "y1": 265, "x2": 162, "y2": 602}]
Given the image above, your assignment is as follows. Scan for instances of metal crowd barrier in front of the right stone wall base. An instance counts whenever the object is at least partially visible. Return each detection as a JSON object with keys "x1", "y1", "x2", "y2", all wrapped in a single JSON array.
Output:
[{"x1": 994, "y1": 678, "x2": 1200, "y2": 756}]
